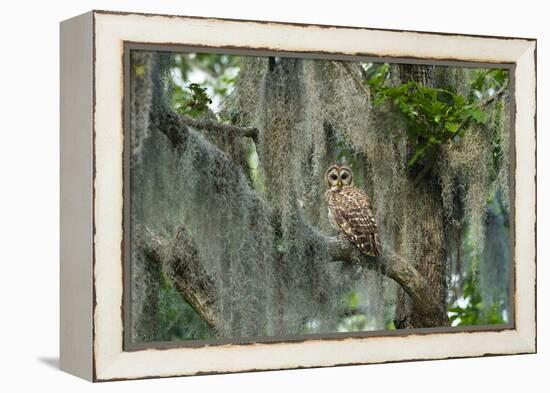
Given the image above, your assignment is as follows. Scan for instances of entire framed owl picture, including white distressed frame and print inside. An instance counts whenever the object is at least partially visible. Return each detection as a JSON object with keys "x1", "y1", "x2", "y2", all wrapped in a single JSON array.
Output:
[{"x1": 60, "y1": 11, "x2": 536, "y2": 381}]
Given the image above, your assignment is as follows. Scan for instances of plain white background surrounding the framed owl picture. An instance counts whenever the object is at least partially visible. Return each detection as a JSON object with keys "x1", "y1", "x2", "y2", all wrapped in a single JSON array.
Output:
[{"x1": 0, "y1": 0, "x2": 550, "y2": 393}]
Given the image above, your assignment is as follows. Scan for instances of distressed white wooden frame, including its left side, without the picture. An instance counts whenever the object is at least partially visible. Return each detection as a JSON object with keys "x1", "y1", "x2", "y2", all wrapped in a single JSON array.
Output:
[{"x1": 60, "y1": 11, "x2": 536, "y2": 381}]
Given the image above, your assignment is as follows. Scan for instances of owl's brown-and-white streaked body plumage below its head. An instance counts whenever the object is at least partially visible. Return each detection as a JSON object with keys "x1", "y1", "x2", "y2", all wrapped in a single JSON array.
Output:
[{"x1": 326, "y1": 186, "x2": 382, "y2": 256}]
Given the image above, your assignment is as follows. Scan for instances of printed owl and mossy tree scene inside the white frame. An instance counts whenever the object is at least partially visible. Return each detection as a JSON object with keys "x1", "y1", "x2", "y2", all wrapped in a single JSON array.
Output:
[{"x1": 125, "y1": 50, "x2": 513, "y2": 344}]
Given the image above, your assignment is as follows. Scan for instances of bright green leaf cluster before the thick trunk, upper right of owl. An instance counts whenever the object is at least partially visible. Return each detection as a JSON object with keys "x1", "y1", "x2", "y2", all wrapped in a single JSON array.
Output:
[{"x1": 367, "y1": 64, "x2": 507, "y2": 166}]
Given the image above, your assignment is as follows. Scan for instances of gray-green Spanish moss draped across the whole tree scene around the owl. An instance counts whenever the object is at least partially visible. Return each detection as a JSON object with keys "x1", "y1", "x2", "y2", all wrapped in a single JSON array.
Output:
[{"x1": 131, "y1": 53, "x2": 509, "y2": 341}]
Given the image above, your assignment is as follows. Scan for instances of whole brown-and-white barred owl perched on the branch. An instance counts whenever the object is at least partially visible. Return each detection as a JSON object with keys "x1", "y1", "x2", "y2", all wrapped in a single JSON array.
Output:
[{"x1": 325, "y1": 165, "x2": 381, "y2": 256}]
